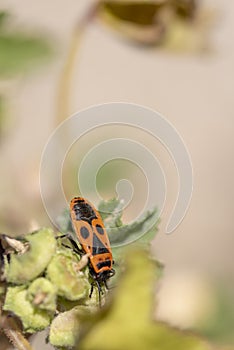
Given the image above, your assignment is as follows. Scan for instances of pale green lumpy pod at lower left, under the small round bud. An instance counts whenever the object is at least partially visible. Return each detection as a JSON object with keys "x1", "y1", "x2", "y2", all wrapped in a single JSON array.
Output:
[{"x1": 3, "y1": 286, "x2": 53, "y2": 333}]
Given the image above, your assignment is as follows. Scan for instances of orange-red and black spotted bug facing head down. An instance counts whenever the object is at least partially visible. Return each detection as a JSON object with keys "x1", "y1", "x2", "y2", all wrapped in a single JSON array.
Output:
[{"x1": 70, "y1": 197, "x2": 115, "y2": 302}]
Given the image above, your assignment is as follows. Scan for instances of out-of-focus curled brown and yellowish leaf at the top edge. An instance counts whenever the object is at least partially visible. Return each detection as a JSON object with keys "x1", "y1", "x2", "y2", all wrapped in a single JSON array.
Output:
[{"x1": 98, "y1": 0, "x2": 210, "y2": 52}]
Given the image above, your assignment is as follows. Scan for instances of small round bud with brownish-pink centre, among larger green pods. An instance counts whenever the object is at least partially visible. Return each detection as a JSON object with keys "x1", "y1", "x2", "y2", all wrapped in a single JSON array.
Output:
[{"x1": 27, "y1": 277, "x2": 57, "y2": 311}]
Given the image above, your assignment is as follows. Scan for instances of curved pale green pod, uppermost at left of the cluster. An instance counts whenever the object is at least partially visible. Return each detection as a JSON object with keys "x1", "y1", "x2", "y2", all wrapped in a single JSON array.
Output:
[{"x1": 4, "y1": 228, "x2": 57, "y2": 284}]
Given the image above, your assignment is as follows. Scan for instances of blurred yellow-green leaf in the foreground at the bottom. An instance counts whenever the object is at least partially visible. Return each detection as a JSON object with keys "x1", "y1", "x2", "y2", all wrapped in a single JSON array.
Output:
[{"x1": 77, "y1": 250, "x2": 216, "y2": 350}]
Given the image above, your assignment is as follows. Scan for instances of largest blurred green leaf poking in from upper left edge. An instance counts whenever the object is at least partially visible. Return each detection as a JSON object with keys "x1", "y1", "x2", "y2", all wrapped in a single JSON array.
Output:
[{"x1": 0, "y1": 32, "x2": 52, "y2": 77}]
